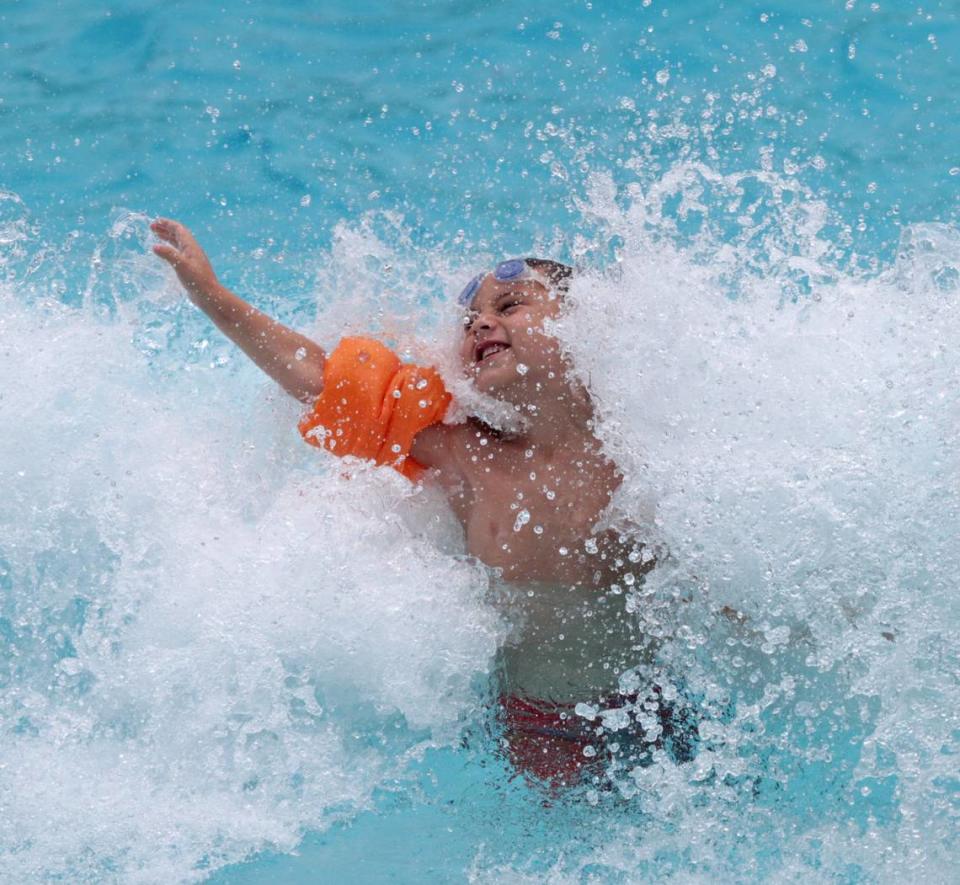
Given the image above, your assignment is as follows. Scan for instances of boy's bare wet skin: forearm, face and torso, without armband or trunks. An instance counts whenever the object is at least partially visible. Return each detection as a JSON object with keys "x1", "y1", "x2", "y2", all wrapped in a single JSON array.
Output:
[{"x1": 151, "y1": 218, "x2": 651, "y2": 703}]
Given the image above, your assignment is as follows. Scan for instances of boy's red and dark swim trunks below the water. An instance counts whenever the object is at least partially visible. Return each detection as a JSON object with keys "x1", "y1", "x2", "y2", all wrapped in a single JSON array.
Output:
[{"x1": 500, "y1": 686, "x2": 696, "y2": 787}]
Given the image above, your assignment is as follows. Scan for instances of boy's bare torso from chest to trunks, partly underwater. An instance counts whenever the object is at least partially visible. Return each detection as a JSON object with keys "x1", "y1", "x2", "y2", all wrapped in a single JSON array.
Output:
[{"x1": 424, "y1": 425, "x2": 650, "y2": 702}]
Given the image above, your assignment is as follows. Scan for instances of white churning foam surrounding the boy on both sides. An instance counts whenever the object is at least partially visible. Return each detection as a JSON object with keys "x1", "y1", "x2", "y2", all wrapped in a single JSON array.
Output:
[{"x1": 0, "y1": 155, "x2": 960, "y2": 881}]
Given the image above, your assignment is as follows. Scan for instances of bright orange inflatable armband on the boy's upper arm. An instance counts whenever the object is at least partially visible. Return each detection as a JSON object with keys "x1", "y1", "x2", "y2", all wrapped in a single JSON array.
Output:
[{"x1": 298, "y1": 338, "x2": 450, "y2": 480}]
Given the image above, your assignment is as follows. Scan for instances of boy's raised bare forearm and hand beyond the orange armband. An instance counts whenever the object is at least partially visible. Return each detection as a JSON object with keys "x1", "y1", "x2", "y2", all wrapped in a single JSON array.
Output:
[{"x1": 150, "y1": 218, "x2": 326, "y2": 402}]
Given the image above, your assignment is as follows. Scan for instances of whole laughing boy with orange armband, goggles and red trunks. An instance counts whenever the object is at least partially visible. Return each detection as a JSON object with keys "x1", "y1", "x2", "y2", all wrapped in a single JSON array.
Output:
[{"x1": 152, "y1": 219, "x2": 683, "y2": 784}]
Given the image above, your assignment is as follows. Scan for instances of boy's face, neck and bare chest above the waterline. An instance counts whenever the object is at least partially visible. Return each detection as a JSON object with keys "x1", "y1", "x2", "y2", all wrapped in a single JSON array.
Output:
[{"x1": 412, "y1": 276, "x2": 621, "y2": 584}]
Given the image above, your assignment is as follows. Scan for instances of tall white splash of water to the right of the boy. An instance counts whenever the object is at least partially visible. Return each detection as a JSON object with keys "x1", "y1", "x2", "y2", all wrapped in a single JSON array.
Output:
[{"x1": 558, "y1": 166, "x2": 960, "y2": 879}]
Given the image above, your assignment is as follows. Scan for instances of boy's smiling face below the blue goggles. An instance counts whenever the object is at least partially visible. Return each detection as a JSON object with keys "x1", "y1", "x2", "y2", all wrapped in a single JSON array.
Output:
[{"x1": 460, "y1": 273, "x2": 566, "y2": 402}]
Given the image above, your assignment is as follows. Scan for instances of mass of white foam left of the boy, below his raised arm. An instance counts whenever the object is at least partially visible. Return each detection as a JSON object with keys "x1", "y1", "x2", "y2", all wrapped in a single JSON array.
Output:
[{"x1": 0, "y1": 282, "x2": 500, "y2": 881}]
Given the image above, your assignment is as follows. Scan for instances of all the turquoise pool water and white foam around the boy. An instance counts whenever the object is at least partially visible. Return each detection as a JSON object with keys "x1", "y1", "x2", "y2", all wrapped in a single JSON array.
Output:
[{"x1": 0, "y1": 0, "x2": 960, "y2": 883}]
